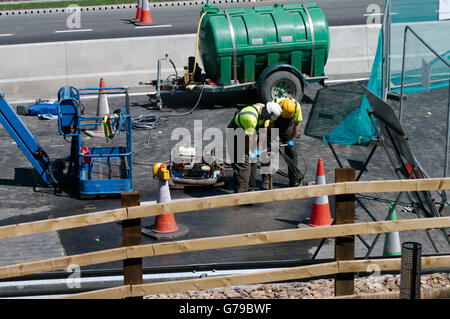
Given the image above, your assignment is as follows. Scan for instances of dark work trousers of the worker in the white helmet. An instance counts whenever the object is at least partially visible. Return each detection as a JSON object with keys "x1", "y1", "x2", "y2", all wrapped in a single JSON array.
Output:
[{"x1": 227, "y1": 117, "x2": 257, "y2": 193}]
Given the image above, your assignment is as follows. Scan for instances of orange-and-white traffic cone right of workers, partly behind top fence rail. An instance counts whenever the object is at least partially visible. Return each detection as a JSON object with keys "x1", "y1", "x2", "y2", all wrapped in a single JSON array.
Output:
[{"x1": 308, "y1": 158, "x2": 333, "y2": 226}]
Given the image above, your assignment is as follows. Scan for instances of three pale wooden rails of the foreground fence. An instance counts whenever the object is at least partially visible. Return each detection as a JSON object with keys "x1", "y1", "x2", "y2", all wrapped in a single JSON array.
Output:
[{"x1": 0, "y1": 178, "x2": 450, "y2": 298}]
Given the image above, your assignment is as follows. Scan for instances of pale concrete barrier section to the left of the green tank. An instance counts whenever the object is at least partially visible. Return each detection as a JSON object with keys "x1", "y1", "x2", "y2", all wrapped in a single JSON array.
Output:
[{"x1": 0, "y1": 34, "x2": 195, "y2": 103}]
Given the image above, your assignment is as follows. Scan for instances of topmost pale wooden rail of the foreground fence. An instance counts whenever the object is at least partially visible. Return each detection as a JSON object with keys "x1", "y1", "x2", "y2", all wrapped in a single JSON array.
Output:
[{"x1": 0, "y1": 178, "x2": 450, "y2": 239}]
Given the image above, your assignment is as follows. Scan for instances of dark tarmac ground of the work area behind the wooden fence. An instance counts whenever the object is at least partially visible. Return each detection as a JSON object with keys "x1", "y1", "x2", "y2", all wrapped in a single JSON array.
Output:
[{"x1": 0, "y1": 79, "x2": 450, "y2": 276}]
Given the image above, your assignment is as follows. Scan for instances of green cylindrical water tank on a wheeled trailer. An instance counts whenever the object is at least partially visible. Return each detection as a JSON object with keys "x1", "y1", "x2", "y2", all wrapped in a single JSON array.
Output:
[{"x1": 146, "y1": 2, "x2": 330, "y2": 108}]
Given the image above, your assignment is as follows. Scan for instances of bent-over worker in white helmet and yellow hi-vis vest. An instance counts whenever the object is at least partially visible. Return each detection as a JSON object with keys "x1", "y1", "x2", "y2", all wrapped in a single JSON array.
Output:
[{"x1": 227, "y1": 102, "x2": 281, "y2": 193}]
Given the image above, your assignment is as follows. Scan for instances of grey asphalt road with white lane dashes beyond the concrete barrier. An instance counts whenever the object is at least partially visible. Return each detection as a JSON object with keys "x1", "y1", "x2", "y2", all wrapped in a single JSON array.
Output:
[{"x1": 0, "y1": 0, "x2": 385, "y2": 45}]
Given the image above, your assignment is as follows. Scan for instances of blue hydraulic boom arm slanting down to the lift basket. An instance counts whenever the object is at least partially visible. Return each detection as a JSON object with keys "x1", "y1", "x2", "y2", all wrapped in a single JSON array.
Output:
[{"x1": 0, "y1": 92, "x2": 56, "y2": 186}]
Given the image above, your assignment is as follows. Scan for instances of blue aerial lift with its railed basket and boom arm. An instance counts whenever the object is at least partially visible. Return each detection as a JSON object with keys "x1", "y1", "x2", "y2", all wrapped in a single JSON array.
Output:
[{"x1": 0, "y1": 86, "x2": 133, "y2": 196}]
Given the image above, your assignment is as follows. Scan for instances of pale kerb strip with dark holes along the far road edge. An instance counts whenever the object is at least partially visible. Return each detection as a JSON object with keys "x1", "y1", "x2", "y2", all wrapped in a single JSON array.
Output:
[{"x1": 0, "y1": 0, "x2": 263, "y2": 16}]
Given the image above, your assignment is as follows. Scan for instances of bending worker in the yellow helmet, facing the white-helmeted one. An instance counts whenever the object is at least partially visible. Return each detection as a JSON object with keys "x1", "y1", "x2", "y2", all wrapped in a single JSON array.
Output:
[{"x1": 261, "y1": 98, "x2": 303, "y2": 189}]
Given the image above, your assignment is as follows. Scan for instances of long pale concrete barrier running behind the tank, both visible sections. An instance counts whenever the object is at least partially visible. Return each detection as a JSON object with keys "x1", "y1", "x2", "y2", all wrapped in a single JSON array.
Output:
[{"x1": 0, "y1": 25, "x2": 381, "y2": 103}]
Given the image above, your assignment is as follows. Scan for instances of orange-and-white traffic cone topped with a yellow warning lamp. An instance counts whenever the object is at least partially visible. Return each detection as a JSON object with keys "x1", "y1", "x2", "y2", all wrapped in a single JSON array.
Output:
[{"x1": 142, "y1": 163, "x2": 189, "y2": 239}]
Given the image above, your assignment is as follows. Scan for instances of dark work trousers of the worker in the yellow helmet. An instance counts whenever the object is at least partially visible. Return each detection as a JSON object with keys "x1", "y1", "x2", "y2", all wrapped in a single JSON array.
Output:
[{"x1": 261, "y1": 116, "x2": 298, "y2": 188}]
